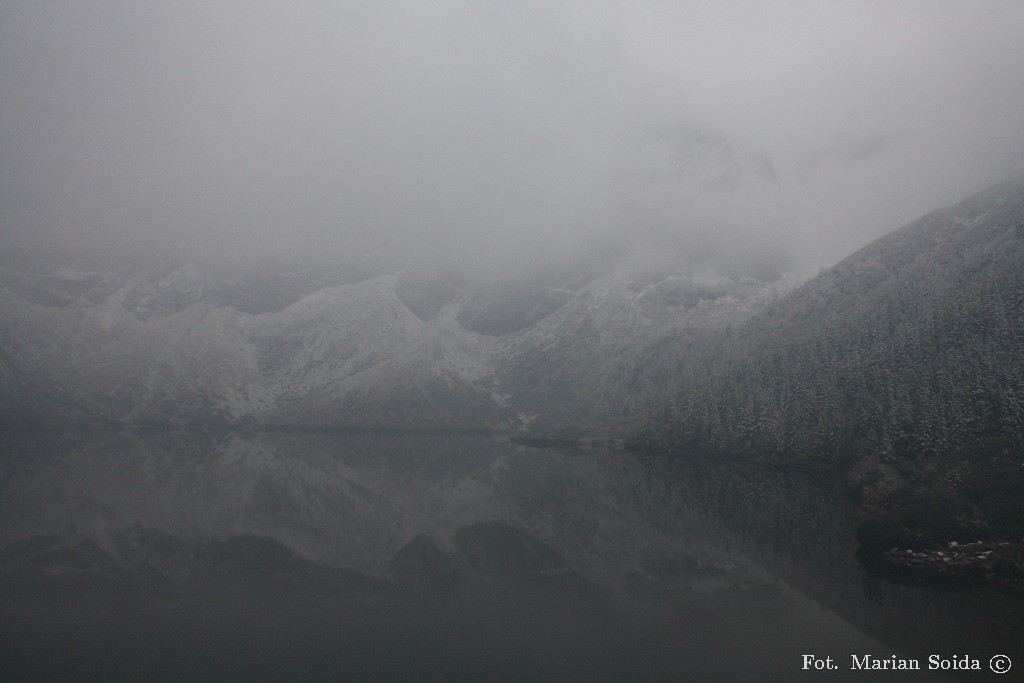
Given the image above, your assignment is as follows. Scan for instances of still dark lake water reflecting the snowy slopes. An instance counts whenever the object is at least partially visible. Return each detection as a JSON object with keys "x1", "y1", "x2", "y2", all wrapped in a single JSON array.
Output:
[{"x1": 0, "y1": 433, "x2": 1024, "y2": 681}]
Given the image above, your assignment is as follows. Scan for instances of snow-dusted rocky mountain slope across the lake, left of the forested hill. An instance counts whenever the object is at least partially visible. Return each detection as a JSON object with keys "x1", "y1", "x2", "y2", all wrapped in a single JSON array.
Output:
[{"x1": 0, "y1": 245, "x2": 795, "y2": 434}]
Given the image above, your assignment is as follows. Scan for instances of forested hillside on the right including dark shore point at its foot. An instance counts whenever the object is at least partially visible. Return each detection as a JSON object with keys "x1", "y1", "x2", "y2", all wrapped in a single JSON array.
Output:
[{"x1": 626, "y1": 178, "x2": 1024, "y2": 565}]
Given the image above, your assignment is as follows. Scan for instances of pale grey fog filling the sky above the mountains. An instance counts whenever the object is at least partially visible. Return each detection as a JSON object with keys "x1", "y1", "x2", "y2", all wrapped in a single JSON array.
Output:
[{"x1": 0, "y1": 0, "x2": 1024, "y2": 271}]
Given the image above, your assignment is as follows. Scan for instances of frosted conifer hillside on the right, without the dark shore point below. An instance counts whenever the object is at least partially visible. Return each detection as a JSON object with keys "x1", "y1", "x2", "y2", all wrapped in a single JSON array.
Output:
[{"x1": 651, "y1": 180, "x2": 1024, "y2": 464}]
